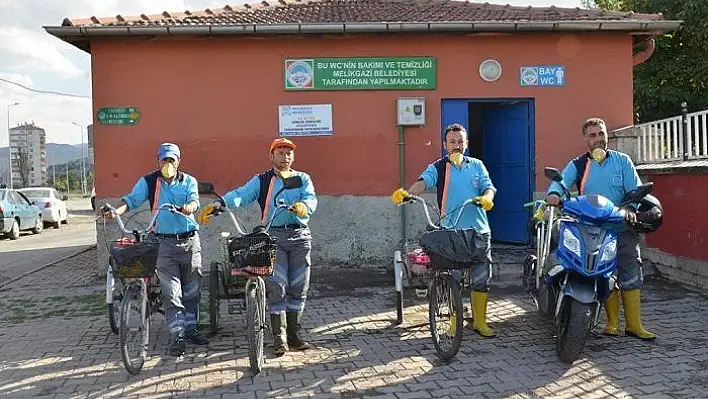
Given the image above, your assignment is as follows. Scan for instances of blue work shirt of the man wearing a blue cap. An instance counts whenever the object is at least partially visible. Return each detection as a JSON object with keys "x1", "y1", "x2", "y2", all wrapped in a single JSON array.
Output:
[{"x1": 123, "y1": 172, "x2": 199, "y2": 234}]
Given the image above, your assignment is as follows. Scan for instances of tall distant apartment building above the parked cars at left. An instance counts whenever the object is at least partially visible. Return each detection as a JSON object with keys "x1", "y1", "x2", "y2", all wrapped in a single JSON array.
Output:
[{"x1": 10, "y1": 122, "x2": 48, "y2": 187}]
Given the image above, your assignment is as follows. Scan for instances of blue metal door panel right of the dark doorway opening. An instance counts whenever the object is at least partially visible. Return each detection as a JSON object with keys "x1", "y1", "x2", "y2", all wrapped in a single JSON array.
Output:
[{"x1": 482, "y1": 100, "x2": 534, "y2": 244}]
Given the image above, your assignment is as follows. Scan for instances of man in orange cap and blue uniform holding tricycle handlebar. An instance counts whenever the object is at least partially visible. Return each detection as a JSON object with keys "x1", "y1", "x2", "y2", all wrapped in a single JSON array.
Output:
[{"x1": 197, "y1": 138, "x2": 317, "y2": 355}]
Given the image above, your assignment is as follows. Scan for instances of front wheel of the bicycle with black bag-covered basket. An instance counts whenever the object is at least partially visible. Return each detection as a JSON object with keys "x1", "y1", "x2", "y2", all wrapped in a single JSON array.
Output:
[{"x1": 428, "y1": 273, "x2": 463, "y2": 361}]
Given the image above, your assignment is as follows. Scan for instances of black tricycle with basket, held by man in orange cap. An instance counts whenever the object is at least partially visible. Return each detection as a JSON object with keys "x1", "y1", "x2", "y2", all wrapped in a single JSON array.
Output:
[{"x1": 199, "y1": 176, "x2": 302, "y2": 375}]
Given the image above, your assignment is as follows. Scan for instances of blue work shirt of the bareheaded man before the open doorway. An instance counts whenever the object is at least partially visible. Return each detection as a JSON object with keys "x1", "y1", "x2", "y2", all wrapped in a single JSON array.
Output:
[{"x1": 420, "y1": 157, "x2": 497, "y2": 234}]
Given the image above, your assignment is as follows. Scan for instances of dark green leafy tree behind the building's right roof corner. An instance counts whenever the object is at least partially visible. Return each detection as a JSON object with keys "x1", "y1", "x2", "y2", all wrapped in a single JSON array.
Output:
[{"x1": 583, "y1": 0, "x2": 708, "y2": 122}]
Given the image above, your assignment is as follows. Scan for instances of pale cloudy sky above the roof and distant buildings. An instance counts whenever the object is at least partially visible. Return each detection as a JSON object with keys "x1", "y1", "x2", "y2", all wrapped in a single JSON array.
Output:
[{"x1": 0, "y1": 0, "x2": 581, "y2": 147}]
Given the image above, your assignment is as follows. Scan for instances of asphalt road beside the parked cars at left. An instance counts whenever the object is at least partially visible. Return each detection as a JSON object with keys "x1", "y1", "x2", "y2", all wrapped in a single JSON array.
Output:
[{"x1": 0, "y1": 198, "x2": 96, "y2": 284}]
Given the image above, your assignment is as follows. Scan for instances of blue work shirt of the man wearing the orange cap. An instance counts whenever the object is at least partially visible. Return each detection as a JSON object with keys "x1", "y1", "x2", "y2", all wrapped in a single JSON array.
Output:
[{"x1": 224, "y1": 170, "x2": 317, "y2": 226}]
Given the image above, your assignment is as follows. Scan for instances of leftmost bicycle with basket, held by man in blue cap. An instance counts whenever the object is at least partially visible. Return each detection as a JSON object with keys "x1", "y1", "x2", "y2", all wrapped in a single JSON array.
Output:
[{"x1": 101, "y1": 204, "x2": 186, "y2": 375}]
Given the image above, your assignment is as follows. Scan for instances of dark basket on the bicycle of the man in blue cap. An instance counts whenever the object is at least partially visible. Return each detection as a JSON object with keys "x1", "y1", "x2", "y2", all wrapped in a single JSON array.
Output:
[{"x1": 109, "y1": 238, "x2": 160, "y2": 278}]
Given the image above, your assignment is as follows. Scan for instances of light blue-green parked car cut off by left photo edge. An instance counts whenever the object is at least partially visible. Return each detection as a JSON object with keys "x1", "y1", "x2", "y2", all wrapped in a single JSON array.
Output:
[{"x1": 0, "y1": 188, "x2": 44, "y2": 240}]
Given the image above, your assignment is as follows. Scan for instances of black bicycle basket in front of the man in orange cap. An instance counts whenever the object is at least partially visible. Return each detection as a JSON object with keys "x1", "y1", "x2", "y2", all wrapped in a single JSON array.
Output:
[{"x1": 228, "y1": 232, "x2": 277, "y2": 276}]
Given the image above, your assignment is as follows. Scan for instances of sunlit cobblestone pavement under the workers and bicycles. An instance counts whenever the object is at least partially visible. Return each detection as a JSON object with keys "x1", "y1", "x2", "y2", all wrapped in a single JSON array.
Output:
[{"x1": 0, "y1": 245, "x2": 708, "y2": 398}]
